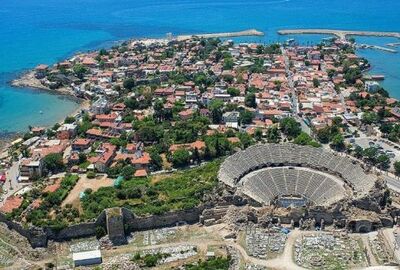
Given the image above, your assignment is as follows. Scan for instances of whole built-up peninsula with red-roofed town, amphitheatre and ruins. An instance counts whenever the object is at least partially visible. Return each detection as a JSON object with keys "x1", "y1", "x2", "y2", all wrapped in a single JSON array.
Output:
[{"x1": 0, "y1": 30, "x2": 400, "y2": 270}]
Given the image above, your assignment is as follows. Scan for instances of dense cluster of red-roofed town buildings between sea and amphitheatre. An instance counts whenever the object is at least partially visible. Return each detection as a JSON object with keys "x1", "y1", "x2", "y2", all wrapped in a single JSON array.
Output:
[{"x1": 0, "y1": 35, "x2": 400, "y2": 215}]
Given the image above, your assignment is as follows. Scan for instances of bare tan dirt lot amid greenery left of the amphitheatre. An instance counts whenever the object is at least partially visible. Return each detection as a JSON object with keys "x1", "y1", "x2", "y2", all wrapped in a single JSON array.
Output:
[{"x1": 61, "y1": 174, "x2": 114, "y2": 210}]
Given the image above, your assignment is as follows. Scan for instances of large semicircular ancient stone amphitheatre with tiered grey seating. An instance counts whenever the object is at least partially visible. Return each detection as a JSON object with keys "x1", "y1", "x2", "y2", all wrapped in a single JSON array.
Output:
[{"x1": 219, "y1": 144, "x2": 377, "y2": 206}]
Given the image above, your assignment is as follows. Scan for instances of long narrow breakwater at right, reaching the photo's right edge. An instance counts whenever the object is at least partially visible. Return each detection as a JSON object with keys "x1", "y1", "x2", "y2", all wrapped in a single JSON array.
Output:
[{"x1": 278, "y1": 29, "x2": 400, "y2": 40}]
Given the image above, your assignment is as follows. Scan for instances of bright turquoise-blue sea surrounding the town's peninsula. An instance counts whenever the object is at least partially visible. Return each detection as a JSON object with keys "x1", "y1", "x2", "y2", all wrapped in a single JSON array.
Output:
[{"x1": 0, "y1": 0, "x2": 400, "y2": 134}]
